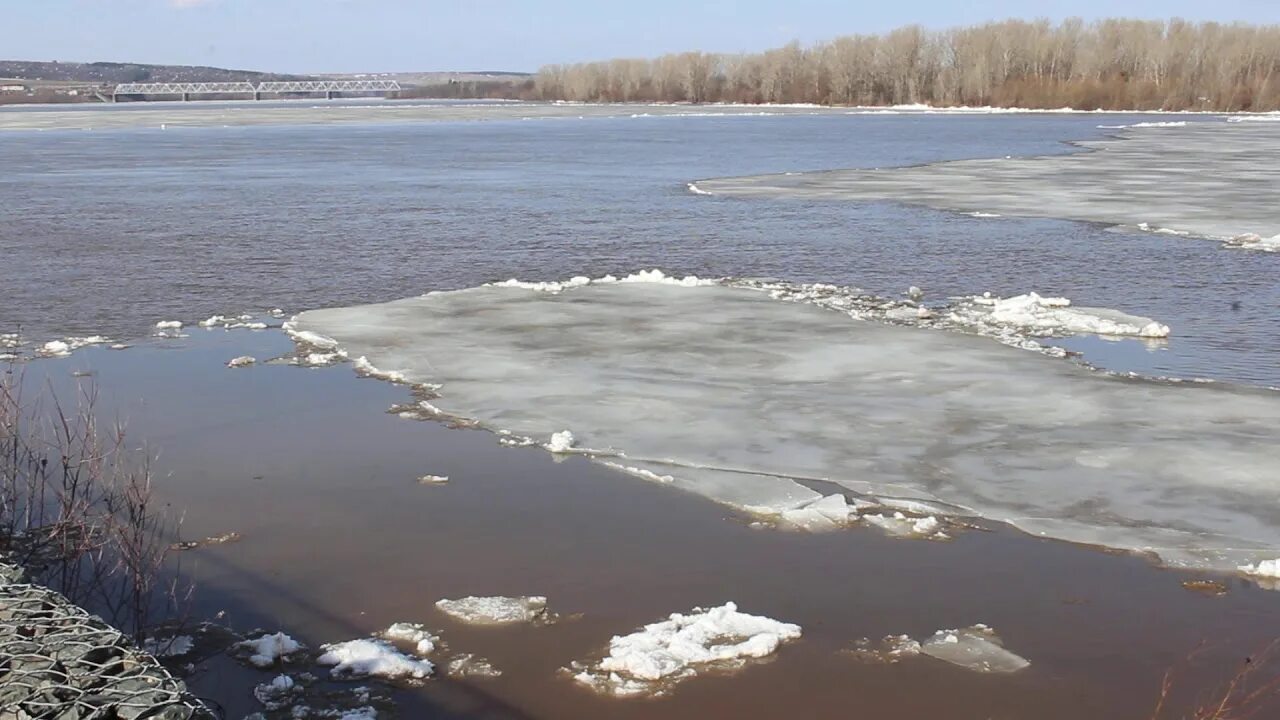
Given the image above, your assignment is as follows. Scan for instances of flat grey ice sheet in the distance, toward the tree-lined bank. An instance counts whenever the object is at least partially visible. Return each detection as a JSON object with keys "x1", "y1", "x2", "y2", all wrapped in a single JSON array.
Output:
[{"x1": 695, "y1": 122, "x2": 1280, "y2": 252}]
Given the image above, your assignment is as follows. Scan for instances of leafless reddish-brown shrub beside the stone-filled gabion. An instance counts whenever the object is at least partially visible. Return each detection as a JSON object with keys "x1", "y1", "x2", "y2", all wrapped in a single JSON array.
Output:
[{"x1": 0, "y1": 369, "x2": 189, "y2": 641}]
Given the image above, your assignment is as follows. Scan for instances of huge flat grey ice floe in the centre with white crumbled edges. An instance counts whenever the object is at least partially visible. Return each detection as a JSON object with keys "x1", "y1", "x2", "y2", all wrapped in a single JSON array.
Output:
[{"x1": 293, "y1": 275, "x2": 1280, "y2": 571}]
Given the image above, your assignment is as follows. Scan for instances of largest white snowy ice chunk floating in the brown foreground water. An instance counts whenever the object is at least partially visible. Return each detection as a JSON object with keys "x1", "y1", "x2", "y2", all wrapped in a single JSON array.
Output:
[{"x1": 567, "y1": 602, "x2": 800, "y2": 696}]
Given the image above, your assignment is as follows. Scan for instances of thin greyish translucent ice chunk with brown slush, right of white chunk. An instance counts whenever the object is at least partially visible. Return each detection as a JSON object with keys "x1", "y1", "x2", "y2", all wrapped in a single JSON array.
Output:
[{"x1": 850, "y1": 624, "x2": 1030, "y2": 674}]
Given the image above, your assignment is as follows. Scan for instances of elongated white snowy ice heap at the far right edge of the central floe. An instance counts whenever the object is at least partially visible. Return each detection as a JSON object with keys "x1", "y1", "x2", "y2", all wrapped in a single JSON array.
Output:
[{"x1": 951, "y1": 292, "x2": 1169, "y2": 338}]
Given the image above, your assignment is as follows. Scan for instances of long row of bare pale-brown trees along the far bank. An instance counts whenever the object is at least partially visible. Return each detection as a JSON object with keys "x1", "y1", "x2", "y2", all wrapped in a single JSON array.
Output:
[{"x1": 535, "y1": 19, "x2": 1280, "y2": 110}]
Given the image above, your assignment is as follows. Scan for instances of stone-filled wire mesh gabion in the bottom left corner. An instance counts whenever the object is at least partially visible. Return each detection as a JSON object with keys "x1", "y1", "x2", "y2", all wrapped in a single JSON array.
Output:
[{"x1": 0, "y1": 573, "x2": 212, "y2": 720}]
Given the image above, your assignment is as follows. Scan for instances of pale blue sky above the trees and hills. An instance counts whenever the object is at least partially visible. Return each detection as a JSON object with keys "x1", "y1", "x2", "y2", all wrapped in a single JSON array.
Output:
[{"x1": 0, "y1": 0, "x2": 1280, "y2": 73}]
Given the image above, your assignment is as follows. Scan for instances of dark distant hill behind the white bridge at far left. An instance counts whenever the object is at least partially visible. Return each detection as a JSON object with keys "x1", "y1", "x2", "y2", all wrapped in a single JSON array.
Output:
[{"x1": 0, "y1": 60, "x2": 312, "y2": 85}]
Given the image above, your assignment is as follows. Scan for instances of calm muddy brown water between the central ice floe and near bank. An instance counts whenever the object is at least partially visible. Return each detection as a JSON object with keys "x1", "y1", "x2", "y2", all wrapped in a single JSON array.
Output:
[{"x1": 17, "y1": 331, "x2": 1280, "y2": 720}]
